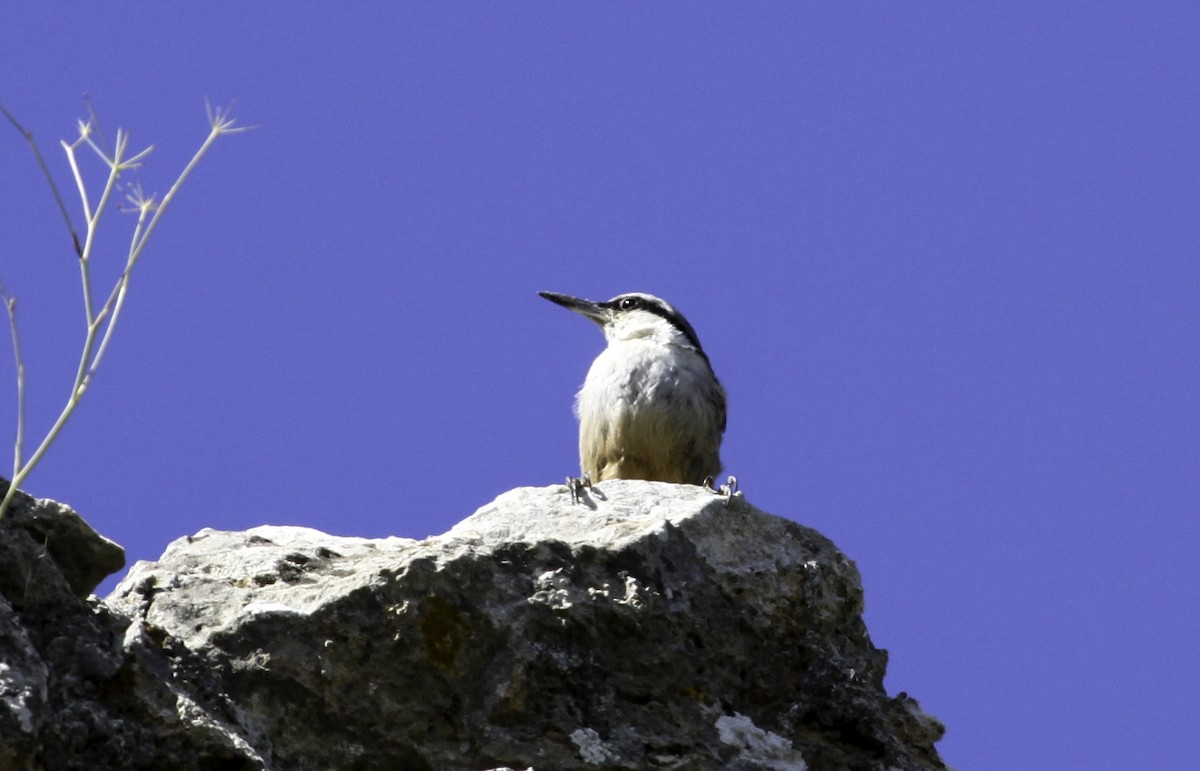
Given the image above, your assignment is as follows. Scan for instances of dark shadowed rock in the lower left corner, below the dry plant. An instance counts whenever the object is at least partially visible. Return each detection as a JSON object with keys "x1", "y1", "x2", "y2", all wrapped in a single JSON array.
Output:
[{"x1": 0, "y1": 484, "x2": 264, "y2": 771}]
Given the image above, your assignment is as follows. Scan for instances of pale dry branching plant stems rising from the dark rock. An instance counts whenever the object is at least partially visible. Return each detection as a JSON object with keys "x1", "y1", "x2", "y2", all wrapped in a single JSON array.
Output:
[{"x1": 0, "y1": 108, "x2": 242, "y2": 518}]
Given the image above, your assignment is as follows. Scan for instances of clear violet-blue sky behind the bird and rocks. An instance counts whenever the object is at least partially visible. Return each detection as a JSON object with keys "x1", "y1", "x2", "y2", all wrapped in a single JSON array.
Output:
[{"x1": 0, "y1": 2, "x2": 1200, "y2": 771}]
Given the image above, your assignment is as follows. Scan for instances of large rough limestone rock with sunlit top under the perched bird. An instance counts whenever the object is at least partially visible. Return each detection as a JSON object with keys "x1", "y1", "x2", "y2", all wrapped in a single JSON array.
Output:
[{"x1": 0, "y1": 480, "x2": 944, "y2": 771}]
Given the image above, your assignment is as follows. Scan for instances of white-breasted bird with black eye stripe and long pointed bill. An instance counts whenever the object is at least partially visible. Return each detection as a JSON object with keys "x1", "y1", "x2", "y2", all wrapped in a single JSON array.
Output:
[{"x1": 538, "y1": 292, "x2": 737, "y2": 492}]
